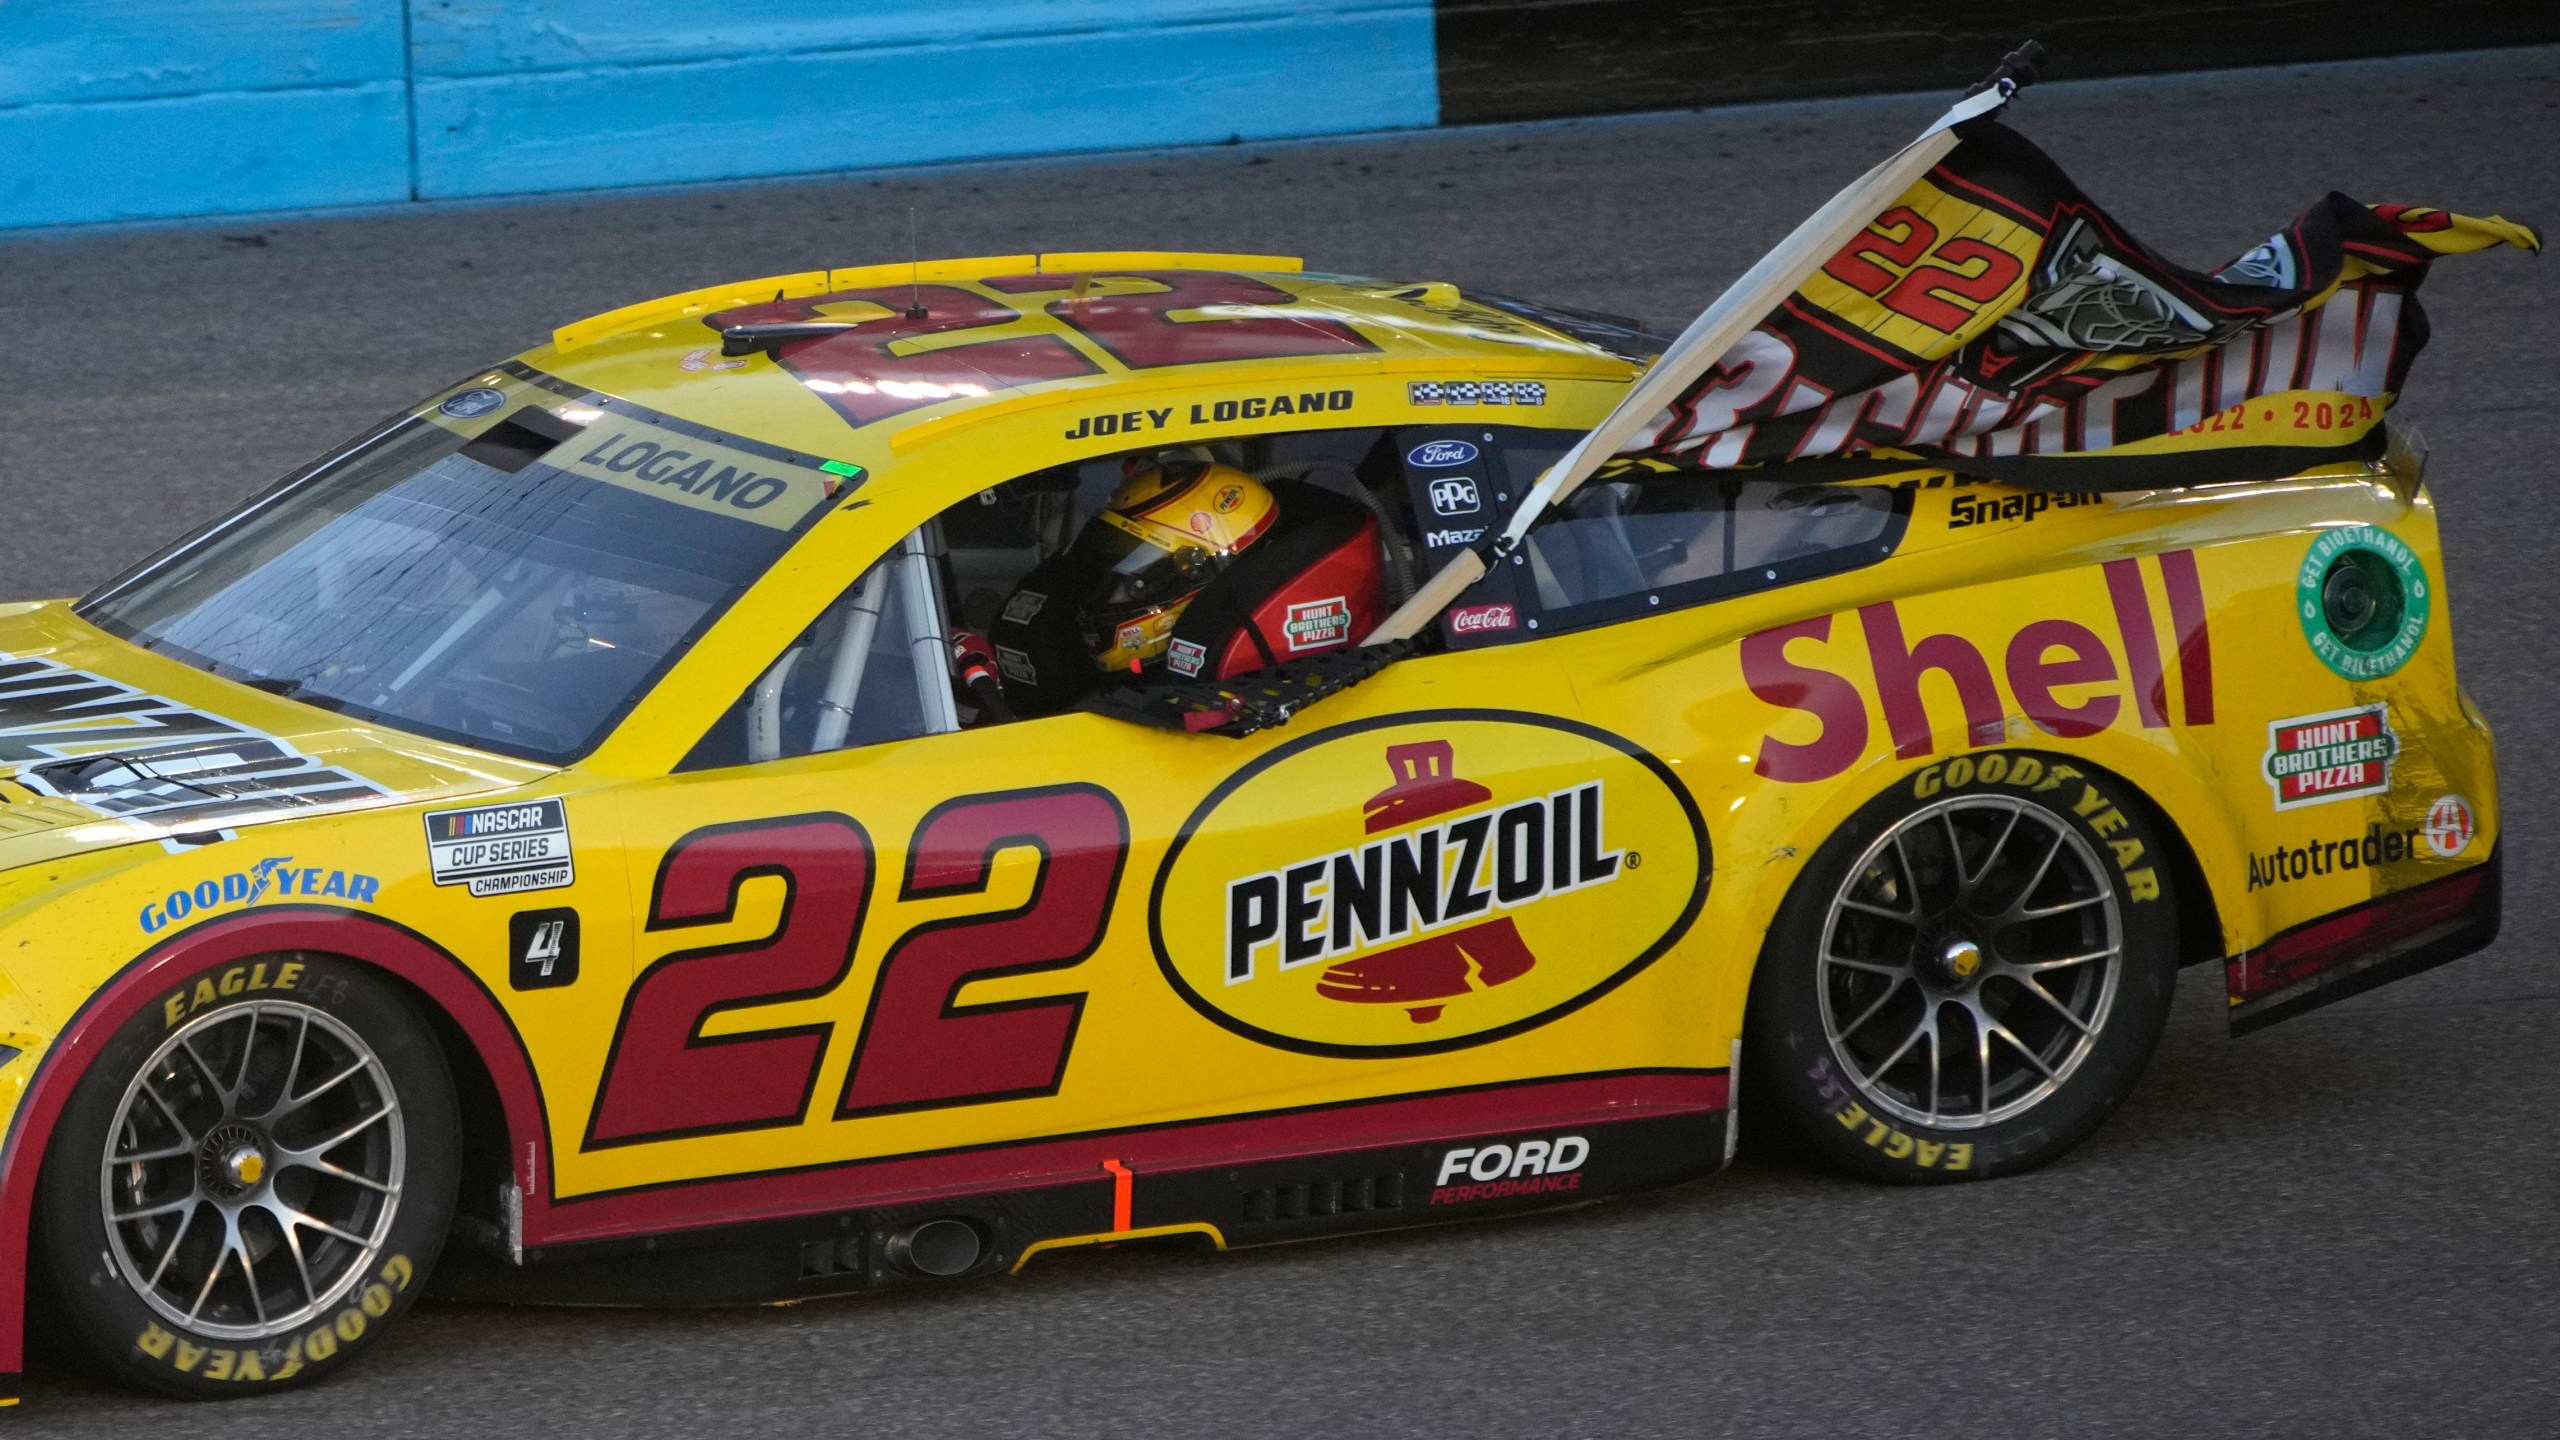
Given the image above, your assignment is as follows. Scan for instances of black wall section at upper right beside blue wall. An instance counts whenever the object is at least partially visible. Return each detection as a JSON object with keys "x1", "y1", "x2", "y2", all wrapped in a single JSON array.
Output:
[{"x1": 1439, "y1": 0, "x2": 2560, "y2": 126}]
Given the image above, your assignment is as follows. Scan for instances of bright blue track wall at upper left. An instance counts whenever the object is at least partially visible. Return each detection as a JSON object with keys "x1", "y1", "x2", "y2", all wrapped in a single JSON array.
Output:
[{"x1": 0, "y1": 0, "x2": 1439, "y2": 225}]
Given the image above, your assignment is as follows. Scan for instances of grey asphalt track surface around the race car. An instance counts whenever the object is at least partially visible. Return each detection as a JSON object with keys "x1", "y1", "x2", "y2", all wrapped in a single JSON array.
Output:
[{"x1": 0, "y1": 49, "x2": 2560, "y2": 1440}]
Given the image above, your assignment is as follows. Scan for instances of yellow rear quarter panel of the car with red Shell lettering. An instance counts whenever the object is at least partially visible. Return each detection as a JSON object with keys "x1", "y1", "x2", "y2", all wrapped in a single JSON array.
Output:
[{"x1": 1541, "y1": 469, "x2": 2499, "y2": 1033}]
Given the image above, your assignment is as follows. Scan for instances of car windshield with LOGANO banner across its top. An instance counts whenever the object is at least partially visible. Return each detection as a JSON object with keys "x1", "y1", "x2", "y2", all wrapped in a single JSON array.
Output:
[{"x1": 79, "y1": 366, "x2": 860, "y2": 764}]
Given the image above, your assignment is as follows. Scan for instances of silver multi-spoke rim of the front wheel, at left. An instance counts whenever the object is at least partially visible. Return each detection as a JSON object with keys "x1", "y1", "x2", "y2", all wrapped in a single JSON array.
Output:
[{"x1": 97, "y1": 983, "x2": 407, "y2": 1340}]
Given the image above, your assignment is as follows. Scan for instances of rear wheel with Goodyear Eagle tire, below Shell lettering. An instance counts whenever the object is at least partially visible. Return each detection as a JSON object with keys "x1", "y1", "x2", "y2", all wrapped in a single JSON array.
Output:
[{"x1": 1743, "y1": 751, "x2": 2176, "y2": 1179}]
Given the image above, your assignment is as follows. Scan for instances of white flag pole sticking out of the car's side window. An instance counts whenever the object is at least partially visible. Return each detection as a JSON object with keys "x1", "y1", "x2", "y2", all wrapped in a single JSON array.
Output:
[{"x1": 1359, "y1": 41, "x2": 2043, "y2": 646}]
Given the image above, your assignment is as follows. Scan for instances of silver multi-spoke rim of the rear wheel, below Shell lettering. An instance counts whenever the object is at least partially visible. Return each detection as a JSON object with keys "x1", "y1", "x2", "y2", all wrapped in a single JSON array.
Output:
[{"x1": 1820, "y1": 794, "x2": 2125, "y2": 1130}]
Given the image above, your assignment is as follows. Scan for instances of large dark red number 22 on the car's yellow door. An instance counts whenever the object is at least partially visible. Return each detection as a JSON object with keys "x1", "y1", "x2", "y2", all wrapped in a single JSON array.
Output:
[{"x1": 586, "y1": 784, "x2": 1129, "y2": 1150}]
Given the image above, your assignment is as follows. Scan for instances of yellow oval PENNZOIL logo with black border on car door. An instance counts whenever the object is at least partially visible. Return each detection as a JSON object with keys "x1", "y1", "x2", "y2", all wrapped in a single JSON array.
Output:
[{"x1": 1149, "y1": 710, "x2": 1708, "y2": 1056}]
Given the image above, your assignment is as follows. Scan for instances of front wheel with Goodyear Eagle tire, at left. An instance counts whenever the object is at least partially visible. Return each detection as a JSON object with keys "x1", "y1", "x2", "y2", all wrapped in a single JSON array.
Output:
[{"x1": 38, "y1": 956, "x2": 456, "y2": 1394}]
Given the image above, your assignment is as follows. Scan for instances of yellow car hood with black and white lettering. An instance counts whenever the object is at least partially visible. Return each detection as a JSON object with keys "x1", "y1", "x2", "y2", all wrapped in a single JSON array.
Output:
[{"x1": 0, "y1": 600, "x2": 553, "y2": 869}]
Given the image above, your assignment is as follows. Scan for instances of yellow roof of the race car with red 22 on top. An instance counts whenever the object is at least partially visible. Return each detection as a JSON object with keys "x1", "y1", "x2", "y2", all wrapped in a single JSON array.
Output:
[{"x1": 522, "y1": 251, "x2": 1659, "y2": 464}]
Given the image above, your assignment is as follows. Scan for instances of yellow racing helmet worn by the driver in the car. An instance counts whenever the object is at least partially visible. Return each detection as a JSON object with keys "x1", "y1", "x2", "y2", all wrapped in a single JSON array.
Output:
[{"x1": 1070, "y1": 456, "x2": 1280, "y2": 671}]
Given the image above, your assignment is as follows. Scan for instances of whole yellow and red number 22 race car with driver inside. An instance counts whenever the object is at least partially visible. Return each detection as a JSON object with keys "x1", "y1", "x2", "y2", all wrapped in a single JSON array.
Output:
[{"x1": 0, "y1": 254, "x2": 2499, "y2": 1396}]
